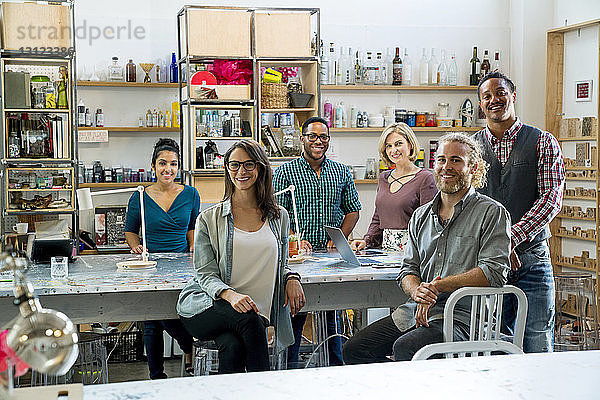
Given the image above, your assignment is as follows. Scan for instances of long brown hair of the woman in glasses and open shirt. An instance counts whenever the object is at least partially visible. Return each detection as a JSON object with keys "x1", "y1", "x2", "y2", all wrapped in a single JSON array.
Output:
[{"x1": 223, "y1": 139, "x2": 281, "y2": 221}]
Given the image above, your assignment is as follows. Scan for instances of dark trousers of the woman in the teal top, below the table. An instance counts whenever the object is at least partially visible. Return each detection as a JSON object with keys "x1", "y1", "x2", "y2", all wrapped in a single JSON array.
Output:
[{"x1": 144, "y1": 319, "x2": 194, "y2": 379}]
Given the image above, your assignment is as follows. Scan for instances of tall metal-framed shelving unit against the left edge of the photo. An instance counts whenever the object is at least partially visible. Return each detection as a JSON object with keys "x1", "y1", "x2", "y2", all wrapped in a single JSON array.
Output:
[{"x1": 0, "y1": 0, "x2": 78, "y2": 248}]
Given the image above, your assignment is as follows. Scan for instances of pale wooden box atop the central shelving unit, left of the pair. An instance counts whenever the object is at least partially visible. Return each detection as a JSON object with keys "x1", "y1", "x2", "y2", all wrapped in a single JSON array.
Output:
[{"x1": 187, "y1": 9, "x2": 251, "y2": 57}]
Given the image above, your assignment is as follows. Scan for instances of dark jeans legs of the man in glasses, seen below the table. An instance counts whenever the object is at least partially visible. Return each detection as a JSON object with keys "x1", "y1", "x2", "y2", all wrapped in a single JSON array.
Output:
[{"x1": 288, "y1": 311, "x2": 344, "y2": 369}]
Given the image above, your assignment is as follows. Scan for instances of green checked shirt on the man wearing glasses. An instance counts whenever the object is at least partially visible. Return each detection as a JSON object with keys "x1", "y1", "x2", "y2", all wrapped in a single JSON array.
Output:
[{"x1": 273, "y1": 157, "x2": 361, "y2": 248}]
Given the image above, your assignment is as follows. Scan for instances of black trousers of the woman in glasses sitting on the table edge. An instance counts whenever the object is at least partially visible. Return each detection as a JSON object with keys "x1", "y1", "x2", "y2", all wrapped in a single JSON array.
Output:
[{"x1": 180, "y1": 300, "x2": 269, "y2": 374}]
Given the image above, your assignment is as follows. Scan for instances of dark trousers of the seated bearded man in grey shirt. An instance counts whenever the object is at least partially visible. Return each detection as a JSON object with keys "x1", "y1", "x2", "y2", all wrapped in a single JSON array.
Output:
[{"x1": 344, "y1": 315, "x2": 469, "y2": 364}]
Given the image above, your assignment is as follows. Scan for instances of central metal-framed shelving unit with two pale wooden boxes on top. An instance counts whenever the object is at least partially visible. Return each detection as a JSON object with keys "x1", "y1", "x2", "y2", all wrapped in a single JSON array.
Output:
[{"x1": 177, "y1": 5, "x2": 321, "y2": 201}]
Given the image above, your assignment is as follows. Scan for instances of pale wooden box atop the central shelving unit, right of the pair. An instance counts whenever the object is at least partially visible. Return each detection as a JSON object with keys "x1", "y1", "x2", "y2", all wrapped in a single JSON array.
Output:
[{"x1": 254, "y1": 12, "x2": 312, "y2": 57}]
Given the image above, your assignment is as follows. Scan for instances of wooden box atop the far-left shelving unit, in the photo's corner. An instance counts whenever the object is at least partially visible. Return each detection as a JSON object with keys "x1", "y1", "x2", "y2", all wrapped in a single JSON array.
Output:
[{"x1": 2, "y1": 3, "x2": 73, "y2": 50}]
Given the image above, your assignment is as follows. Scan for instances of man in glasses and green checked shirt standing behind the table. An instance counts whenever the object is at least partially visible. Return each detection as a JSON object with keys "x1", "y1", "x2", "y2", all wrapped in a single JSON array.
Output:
[{"x1": 273, "y1": 117, "x2": 361, "y2": 367}]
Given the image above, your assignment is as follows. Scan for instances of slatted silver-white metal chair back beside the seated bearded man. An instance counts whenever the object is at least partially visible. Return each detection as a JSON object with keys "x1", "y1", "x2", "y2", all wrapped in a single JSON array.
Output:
[{"x1": 444, "y1": 285, "x2": 527, "y2": 349}]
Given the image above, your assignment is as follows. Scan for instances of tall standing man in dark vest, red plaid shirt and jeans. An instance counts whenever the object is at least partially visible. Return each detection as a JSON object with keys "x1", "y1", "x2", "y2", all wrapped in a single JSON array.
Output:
[{"x1": 475, "y1": 72, "x2": 565, "y2": 353}]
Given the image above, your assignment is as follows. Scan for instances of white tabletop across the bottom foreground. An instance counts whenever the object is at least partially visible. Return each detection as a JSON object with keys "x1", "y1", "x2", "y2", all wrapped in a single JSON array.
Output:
[{"x1": 83, "y1": 351, "x2": 600, "y2": 400}]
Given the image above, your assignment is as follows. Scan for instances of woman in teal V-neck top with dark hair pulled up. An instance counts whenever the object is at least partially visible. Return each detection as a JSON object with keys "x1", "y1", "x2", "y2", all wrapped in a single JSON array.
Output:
[{"x1": 125, "y1": 139, "x2": 200, "y2": 379}]
